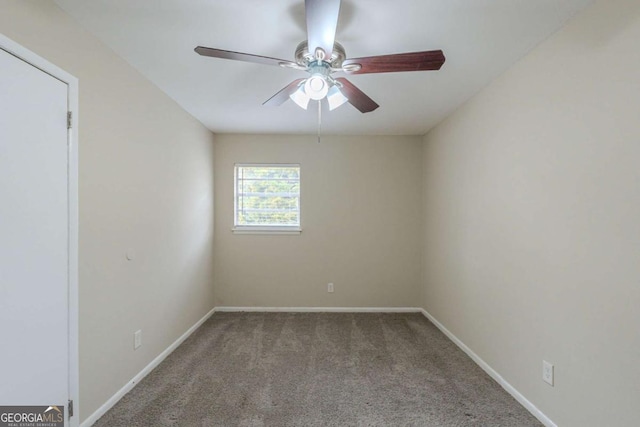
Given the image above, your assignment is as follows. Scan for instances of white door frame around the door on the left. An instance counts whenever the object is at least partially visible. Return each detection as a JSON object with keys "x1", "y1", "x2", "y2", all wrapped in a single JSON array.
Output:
[{"x1": 0, "y1": 33, "x2": 80, "y2": 427}]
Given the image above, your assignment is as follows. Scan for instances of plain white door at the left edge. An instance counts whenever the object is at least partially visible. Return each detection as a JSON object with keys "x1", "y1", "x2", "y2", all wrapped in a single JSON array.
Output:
[{"x1": 0, "y1": 49, "x2": 70, "y2": 412}]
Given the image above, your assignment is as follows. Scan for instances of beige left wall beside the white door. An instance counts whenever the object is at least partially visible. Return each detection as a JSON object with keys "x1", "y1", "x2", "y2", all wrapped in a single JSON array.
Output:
[{"x1": 0, "y1": 0, "x2": 213, "y2": 419}]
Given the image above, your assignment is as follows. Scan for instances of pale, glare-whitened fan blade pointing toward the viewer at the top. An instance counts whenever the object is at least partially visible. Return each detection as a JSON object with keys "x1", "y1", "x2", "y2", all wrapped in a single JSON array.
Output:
[{"x1": 304, "y1": 0, "x2": 340, "y2": 59}]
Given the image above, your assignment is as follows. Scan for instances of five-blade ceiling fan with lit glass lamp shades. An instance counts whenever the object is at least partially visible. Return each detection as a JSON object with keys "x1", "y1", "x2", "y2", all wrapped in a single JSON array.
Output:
[{"x1": 195, "y1": 0, "x2": 445, "y2": 113}]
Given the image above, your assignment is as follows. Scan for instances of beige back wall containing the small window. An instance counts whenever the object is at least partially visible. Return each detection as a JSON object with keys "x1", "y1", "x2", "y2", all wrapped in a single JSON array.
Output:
[{"x1": 215, "y1": 135, "x2": 422, "y2": 307}]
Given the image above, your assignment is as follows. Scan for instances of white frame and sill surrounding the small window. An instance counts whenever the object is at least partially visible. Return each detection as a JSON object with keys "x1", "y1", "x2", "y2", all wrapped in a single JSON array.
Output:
[{"x1": 231, "y1": 163, "x2": 302, "y2": 234}]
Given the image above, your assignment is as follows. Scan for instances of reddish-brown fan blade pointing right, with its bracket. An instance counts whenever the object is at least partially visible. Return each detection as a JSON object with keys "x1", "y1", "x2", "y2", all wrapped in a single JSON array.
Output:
[{"x1": 342, "y1": 50, "x2": 445, "y2": 74}]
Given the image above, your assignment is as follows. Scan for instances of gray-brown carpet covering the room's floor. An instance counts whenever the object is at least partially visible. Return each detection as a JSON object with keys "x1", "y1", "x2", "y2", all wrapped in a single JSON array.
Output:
[{"x1": 95, "y1": 313, "x2": 542, "y2": 427}]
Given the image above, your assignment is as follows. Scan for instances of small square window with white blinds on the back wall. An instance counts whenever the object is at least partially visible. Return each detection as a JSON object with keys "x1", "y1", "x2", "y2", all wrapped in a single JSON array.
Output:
[{"x1": 233, "y1": 164, "x2": 300, "y2": 233}]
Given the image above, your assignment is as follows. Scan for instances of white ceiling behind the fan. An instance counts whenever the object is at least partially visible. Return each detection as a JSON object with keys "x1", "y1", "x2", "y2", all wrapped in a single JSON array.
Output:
[{"x1": 56, "y1": 0, "x2": 593, "y2": 135}]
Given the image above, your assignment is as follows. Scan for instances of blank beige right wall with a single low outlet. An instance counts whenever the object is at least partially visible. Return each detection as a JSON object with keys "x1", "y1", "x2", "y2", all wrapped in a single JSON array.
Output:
[{"x1": 423, "y1": 0, "x2": 640, "y2": 427}]
